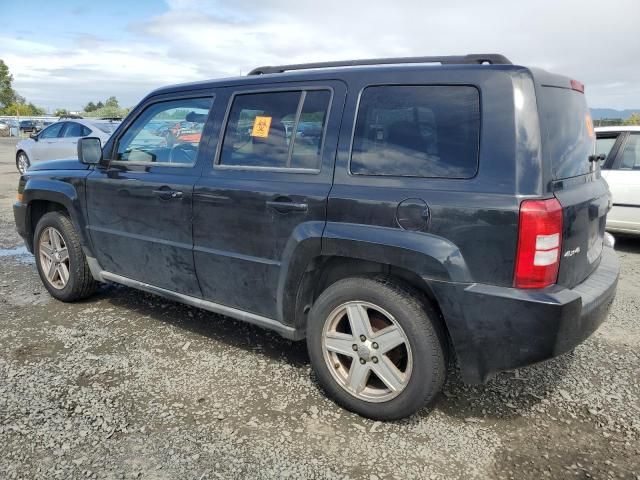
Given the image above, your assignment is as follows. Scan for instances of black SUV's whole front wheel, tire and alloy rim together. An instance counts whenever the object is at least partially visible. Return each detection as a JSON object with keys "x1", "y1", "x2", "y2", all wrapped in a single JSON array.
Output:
[{"x1": 33, "y1": 212, "x2": 97, "y2": 302}]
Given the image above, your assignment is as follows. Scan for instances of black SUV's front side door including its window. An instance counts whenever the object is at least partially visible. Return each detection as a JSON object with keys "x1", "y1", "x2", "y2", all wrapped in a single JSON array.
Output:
[{"x1": 87, "y1": 95, "x2": 213, "y2": 296}]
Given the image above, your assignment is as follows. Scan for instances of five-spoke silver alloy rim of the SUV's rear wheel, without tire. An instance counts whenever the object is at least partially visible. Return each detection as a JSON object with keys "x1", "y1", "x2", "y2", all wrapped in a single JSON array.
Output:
[{"x1": 322, "y1": 301, "x2": 413, "y2": 402}]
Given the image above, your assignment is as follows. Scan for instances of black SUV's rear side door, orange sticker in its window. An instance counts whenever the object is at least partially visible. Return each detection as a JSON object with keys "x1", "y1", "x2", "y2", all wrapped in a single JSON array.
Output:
[{"x1": 193, "y1": 82, "x2": 345, "y2": 319}]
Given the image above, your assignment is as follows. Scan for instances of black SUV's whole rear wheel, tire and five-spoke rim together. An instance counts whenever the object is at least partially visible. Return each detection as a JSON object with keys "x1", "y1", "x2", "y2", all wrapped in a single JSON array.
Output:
[{"x1": 307, "y1": 277, "x2": 446, "y2": 420}]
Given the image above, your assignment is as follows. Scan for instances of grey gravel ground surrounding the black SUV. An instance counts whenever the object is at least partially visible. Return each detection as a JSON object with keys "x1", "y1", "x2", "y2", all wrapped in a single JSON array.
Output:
[{"x1": 0, "y1": 139, "x2": 640, "y2": 480}]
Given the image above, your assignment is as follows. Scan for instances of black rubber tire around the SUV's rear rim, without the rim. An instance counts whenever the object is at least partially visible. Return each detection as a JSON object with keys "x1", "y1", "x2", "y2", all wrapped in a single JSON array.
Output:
[{"x1": 307, "y1": 276, "x2": 447, "y2": 420}]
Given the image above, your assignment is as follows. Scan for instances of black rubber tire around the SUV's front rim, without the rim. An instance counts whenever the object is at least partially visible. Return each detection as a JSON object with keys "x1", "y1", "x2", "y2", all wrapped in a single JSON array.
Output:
[{"x1": 33, "y1": 212, "x2": 98, "y2": 302}]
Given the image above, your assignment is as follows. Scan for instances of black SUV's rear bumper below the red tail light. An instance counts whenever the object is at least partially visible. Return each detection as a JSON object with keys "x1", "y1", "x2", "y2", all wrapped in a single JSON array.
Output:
[{"x1": 435, "y1": 247, "x2": 620, "y2": 383}]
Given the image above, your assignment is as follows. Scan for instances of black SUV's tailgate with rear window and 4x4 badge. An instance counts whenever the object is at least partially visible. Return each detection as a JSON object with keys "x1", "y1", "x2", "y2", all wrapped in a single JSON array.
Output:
[{"x1": 537, "y1": 81, "x2": 611, "y2": 288}]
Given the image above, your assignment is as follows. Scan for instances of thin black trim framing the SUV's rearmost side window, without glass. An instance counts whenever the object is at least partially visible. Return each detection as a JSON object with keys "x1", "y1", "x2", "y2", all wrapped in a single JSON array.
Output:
[{"x1": 347, "y1": 83, "x2": 483, "y2": 180}]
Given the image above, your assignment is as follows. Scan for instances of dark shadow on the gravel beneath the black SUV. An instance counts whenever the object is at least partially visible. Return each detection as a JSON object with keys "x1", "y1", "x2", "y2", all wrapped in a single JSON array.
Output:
[{"x1": 93, "y1": 285, "x2": 574, "y2": 424}]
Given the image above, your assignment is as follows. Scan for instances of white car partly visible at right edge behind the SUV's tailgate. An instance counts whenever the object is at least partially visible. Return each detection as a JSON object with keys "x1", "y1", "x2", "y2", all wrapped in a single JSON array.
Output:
[{"x1": 595, "y1": 126, "x2": 640, "y2": 235}]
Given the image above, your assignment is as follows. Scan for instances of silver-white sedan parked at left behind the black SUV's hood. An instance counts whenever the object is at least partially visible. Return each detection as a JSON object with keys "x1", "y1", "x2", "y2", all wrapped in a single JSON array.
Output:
[{"x1": 16, "y1": 118, "x2": 120, "y2": 173}]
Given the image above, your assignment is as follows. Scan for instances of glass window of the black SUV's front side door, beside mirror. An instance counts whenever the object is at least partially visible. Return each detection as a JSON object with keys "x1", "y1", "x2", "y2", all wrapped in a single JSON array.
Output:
[{"x1": 115, "y1": 98, "x2": 213, "y2": 165}]
